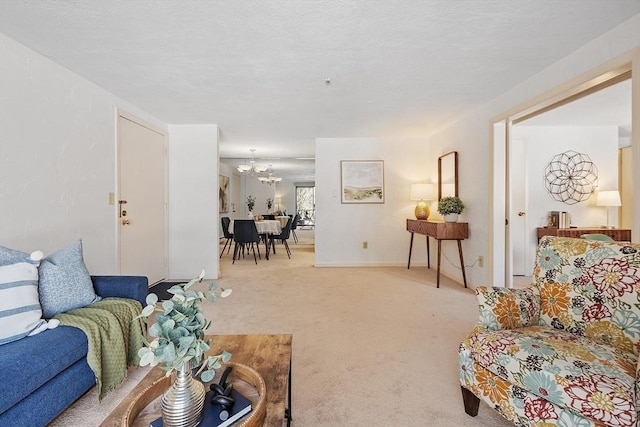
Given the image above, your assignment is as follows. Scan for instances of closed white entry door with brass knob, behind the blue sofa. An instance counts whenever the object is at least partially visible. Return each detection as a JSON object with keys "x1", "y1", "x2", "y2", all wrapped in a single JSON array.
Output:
[{"x1": 117, "y1": 115, "x2": 166, "y2": 284}]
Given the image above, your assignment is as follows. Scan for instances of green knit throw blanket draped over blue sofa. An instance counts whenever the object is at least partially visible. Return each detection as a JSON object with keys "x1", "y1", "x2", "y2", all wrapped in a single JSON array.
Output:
[{"x1": 54, "y1": 298, "x2": 145, "y2": 401}]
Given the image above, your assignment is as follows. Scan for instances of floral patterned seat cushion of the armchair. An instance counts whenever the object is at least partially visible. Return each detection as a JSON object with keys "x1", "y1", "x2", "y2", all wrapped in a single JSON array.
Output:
[{"x1": 469, "y1": 326, "x2": 637, "y2": 426}]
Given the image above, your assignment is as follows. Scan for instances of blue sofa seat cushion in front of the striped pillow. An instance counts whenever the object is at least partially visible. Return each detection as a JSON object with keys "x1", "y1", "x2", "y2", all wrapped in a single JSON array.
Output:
[{"x1": 0, "y1": 326, "x2": 87, "y2": 413}]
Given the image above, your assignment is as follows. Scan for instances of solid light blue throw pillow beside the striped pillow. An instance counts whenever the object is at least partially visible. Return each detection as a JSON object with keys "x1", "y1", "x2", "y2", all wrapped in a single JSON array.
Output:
[{"x1": 0, "y1": 240, "x2": 100, "y2": 319}]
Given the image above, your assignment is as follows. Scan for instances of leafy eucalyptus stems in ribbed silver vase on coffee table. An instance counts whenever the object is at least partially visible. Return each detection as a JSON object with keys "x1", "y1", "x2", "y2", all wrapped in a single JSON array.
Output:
[{"x1": 138, "y1": 270, "x2": 231, "y2": 426}]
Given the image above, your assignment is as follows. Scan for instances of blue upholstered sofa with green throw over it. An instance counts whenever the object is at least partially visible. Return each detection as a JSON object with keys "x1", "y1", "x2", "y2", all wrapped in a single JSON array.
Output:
[{"x1": 0, "y1": 276, "x2": 148, "y2": 427}]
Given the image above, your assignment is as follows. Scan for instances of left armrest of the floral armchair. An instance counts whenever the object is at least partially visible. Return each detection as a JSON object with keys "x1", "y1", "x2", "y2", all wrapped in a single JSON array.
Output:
[{"x1": 476, "y1": 286, "x2": 540, "y2": 331}]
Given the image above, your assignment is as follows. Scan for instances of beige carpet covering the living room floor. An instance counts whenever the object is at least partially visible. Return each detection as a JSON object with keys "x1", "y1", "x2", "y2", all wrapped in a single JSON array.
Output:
[{"x1": 48, "y1": 230, "x2": 511, "y2": 427}]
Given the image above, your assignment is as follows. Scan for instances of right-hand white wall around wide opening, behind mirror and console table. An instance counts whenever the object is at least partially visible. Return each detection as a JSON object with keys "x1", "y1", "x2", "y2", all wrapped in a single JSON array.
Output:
[{"x1": 429, "y1": 15, "x2": 640, "y2": 284}]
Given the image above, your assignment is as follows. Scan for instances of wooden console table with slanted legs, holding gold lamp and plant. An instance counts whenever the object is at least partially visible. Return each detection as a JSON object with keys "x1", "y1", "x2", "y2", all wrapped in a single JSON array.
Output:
[{"x1": 407, "y1": 219, "x2": 469, "y2": 288}]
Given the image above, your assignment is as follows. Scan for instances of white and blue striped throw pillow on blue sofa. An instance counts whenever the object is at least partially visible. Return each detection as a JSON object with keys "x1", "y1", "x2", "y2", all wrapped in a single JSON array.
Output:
[{"x1": 0, "y1": 260, "x2": 47, "y2": 345}]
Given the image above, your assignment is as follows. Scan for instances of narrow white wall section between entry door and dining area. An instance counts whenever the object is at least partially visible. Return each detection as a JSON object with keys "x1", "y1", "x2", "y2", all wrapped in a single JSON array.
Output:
[{"x1": 169, "y1": 125, "x2": 220, "y2": 280}]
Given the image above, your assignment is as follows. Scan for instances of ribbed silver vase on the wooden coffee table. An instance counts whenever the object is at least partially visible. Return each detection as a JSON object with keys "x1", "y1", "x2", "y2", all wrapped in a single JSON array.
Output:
[{"x1": 162, "y1": 365, "x2": 205, "y2": 427}]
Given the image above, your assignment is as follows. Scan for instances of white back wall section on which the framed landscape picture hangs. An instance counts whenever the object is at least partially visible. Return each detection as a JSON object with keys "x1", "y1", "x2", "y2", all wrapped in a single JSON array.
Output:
[{"x1": 315, "y1": 138, "x2": 435, "y2": 266}]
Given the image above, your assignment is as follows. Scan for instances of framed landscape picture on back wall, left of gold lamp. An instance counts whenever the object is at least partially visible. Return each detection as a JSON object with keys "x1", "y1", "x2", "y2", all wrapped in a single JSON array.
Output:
[{"x1": 340, "y1": 160, "x2": 384, "y2": 203}]
